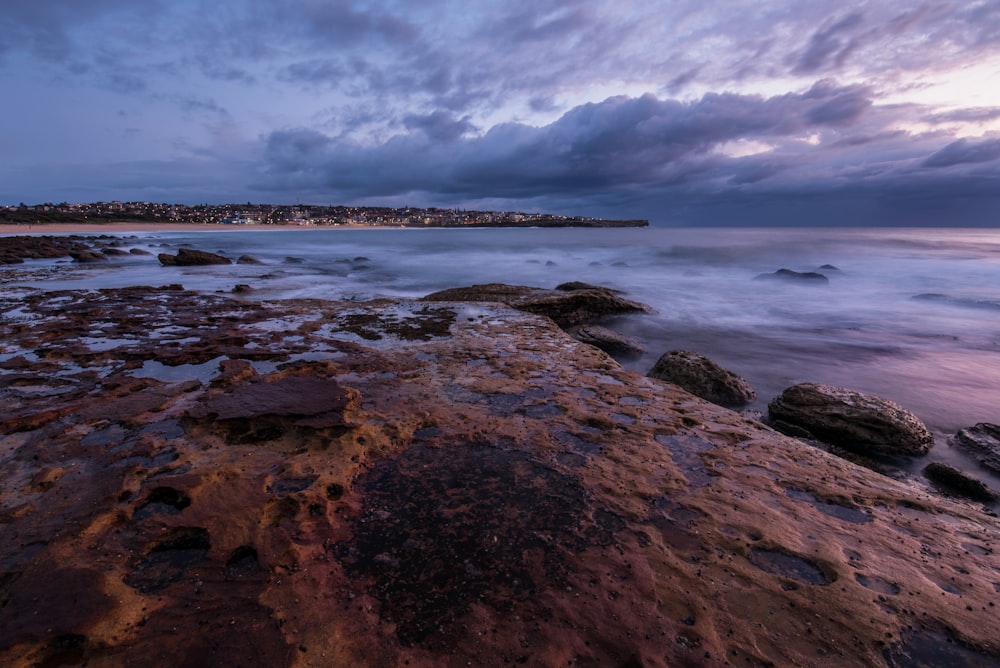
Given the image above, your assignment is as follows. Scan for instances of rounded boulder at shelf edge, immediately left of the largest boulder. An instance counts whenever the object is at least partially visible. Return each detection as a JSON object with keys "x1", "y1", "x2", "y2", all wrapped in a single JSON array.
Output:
[{"x1": 646, "y1": 350, "x2": 757, "y2": 406}]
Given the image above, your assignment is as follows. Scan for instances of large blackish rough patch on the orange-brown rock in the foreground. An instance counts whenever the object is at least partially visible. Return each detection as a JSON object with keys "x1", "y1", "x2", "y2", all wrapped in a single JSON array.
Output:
[{"x1": 331, "y1": 445, "x2": 600, "y2": 645}]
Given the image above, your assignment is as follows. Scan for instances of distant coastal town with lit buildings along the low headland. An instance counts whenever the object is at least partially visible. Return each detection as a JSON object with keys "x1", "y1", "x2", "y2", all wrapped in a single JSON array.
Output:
[{"x1": 0, "y1": 201, "x2": 649, "y2": 227}]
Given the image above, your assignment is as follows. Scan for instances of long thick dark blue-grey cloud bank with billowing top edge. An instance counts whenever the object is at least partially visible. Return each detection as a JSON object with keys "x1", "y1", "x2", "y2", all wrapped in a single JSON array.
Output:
[{"x1": 268, "y1": 82, "x2": 884, "y2": 197}]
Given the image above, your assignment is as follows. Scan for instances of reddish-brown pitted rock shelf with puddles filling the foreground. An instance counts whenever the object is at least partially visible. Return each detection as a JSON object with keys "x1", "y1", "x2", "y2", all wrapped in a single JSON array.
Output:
[{"x1": 0, "y1": 234, "x2": 1000, "y2": 666}]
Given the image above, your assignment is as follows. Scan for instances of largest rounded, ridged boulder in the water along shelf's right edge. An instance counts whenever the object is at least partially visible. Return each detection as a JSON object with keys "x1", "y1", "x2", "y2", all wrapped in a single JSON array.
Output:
[{"x1": 768, "y1": 383, "x2": 934, "y2": 456}]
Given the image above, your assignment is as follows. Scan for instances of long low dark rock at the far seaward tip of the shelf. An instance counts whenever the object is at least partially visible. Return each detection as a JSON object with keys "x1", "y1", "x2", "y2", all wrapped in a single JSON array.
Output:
[{"x1": 422, "y1": 283, "x2": 652, "y2": 329}]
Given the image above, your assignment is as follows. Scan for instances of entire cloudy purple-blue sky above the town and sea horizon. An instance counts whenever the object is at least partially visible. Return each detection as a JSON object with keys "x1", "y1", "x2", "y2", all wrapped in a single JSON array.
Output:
[{"x1": 0, "y1": 0, "x2": 1000, "y2": 225}]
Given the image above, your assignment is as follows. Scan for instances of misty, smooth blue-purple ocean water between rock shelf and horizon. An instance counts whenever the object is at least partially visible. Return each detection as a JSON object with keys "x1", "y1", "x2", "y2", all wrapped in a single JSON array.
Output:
[{"x1": 0, "y1": 227, "x2": 1000, "y2": 488}]
